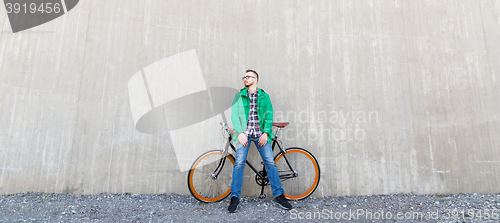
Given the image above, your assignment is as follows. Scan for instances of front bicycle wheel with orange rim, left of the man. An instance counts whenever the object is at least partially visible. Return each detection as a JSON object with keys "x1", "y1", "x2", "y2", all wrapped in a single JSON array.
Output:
[{"x1": 188, "y1": 150, "x2": 234, "y2": 203}]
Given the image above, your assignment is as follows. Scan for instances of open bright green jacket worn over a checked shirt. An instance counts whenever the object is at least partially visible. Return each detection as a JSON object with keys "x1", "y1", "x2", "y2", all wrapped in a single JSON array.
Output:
[{"x1": 231, "y1": 88, "x2": 273, "y2": 143}]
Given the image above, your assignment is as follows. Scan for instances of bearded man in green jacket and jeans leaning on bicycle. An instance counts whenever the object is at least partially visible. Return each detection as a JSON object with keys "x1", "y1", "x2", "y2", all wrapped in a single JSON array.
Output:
[{"x1": 228, "y1": 70, "x2": 292, "y2": 213}]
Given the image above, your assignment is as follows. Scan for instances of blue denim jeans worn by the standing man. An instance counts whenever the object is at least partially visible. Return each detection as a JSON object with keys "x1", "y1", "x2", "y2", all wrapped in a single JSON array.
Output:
[{"x1": 231, "y1": 137, "x2": 285, "y2": 198}]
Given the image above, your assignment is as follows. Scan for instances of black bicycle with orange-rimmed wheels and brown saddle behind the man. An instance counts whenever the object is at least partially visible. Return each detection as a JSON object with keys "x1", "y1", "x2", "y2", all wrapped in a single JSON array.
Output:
[{"x1": 187, "y1": 122, "x2": 320, "y2": 203}]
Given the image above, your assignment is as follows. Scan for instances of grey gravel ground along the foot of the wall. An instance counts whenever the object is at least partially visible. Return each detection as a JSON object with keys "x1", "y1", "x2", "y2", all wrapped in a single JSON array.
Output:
[{"x1": 0, "y1": 193, "x2": 500, "y2": 222}]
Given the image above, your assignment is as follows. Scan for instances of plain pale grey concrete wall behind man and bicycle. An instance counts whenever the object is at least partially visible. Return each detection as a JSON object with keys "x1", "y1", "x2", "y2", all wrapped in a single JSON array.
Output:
[{"x1": 0, "y1": 0, "x2": 500, "y2": 196}]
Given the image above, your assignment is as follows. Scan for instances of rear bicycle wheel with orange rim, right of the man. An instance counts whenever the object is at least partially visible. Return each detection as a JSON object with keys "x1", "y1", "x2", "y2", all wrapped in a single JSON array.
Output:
[{"x1": 274, "y1": 147, "x2": 320, "y2": 200}]
